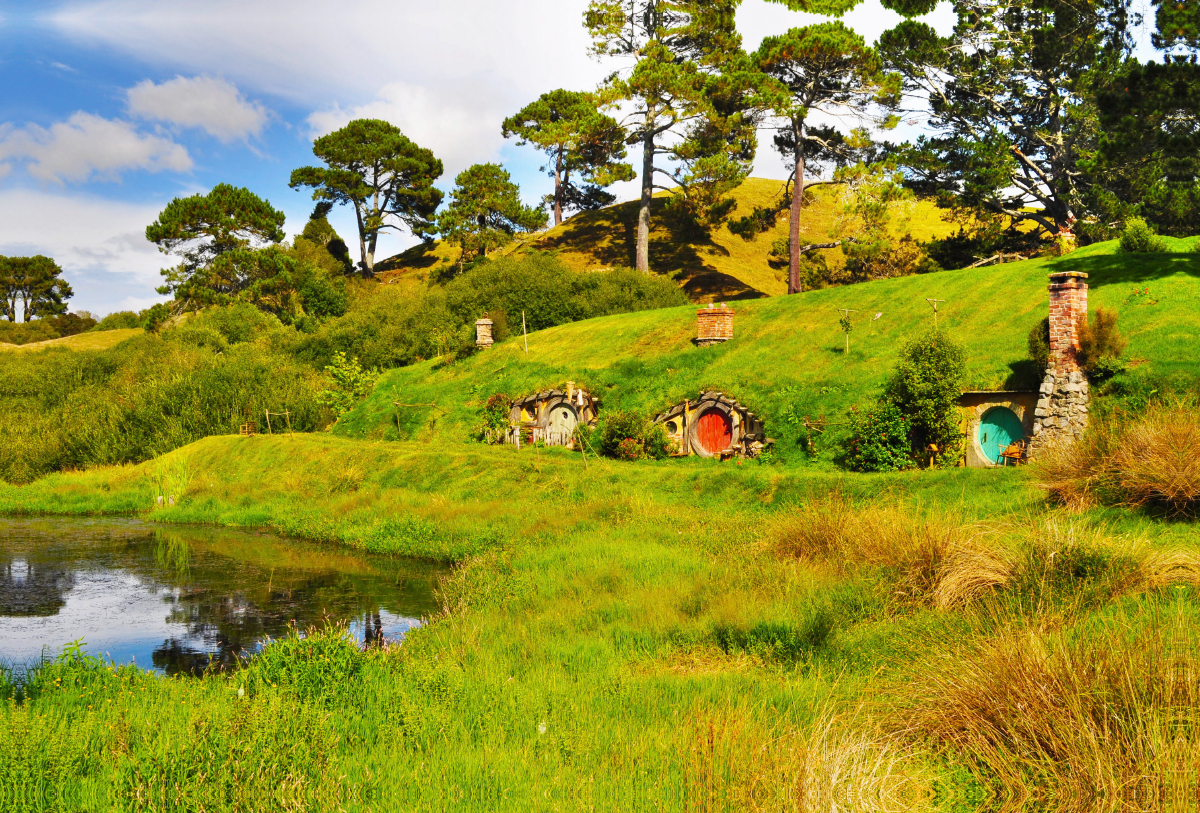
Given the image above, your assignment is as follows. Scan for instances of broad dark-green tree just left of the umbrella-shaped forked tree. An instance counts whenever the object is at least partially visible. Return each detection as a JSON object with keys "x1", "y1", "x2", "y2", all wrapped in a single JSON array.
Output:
[{"x1": 146, "y1": 183, "x2": 284, "y2": 307}]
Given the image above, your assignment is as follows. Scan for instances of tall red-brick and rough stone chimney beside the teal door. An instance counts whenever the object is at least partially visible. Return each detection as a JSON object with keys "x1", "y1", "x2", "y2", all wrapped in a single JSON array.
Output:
[{"x1": 1031, "y1": 271, "x2": 1090, "y2": 452}]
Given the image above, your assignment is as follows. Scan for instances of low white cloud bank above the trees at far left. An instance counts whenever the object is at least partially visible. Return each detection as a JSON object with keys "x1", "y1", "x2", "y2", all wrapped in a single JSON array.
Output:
[{"x1": 0, "y1": 189, "x2": 172, "y2": 314}]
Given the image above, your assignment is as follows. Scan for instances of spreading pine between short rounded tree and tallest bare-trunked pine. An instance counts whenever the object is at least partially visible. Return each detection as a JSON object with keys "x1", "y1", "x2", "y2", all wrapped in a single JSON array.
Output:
[{"x1": 502, "y1": 90, "x2": 634, "y2": 225}]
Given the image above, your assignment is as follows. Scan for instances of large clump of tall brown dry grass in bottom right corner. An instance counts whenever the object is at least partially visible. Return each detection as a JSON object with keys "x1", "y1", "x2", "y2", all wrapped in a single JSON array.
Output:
[{"x1": 894, "y1": 612, "x2": 1200, "y2": 813}]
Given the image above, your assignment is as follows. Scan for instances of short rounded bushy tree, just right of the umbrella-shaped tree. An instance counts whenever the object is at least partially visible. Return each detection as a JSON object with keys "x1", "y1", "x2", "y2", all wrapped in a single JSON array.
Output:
[{"x1": 438, "y1": 164, "x2": 546, "y2": 267}]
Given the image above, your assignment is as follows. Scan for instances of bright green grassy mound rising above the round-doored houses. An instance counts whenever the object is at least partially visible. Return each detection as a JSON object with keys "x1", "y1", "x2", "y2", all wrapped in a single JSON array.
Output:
[{"x1": 336, "y1": 241, "x2": 1200, "y2": 456}]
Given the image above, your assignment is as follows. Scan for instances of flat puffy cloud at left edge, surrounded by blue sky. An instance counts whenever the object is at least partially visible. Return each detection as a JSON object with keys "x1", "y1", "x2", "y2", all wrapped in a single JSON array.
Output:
[{"x1": 0, "y1": 112, "x2": 192, "y2": 183}]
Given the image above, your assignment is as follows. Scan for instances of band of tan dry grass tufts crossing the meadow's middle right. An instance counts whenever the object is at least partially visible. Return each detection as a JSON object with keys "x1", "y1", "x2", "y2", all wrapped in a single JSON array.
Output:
[{"x1": 775, "y1": 492, "x2": 1200, "y2": 609}]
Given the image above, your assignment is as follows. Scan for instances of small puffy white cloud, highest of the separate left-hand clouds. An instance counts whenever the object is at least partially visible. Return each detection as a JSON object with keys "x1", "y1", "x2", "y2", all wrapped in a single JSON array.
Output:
[{"x1": 127, "y1": 76, "x2": 269, "y2": 144}]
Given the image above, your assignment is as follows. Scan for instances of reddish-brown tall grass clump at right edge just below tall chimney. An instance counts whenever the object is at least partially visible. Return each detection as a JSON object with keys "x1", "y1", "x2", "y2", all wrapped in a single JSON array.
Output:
[{"x1": 1034, "y1": 404, "x2": 1200, "y2": 516}]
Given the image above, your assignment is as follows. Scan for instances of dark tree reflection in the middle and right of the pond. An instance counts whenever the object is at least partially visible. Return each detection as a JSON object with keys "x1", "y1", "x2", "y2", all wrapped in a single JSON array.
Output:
[{"x1": 147, "y1": 575, "x2": 383, "y2": 674}]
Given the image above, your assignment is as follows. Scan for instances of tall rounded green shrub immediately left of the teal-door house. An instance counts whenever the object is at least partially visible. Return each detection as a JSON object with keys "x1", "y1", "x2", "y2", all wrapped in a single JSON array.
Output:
[{"x1": 883, "y1": 329, "x2": 966, "y2": 465}]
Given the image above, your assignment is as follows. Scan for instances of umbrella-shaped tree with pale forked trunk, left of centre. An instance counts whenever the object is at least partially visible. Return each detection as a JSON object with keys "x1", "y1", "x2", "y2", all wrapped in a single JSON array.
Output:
[{"x1": 289, "y1": 119, "x2": 443, "y2": 277}]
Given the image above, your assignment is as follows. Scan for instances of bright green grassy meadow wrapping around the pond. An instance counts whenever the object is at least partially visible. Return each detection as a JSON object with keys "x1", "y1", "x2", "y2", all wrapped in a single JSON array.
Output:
[{"x1": 0, "y1": 435, "x2": 1200, "y2": 811}]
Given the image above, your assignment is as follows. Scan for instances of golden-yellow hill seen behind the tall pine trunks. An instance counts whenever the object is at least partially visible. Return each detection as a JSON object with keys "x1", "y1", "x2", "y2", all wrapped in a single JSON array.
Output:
[{"x1": 378, "y1": 177, "x2": 954, "y2": 302}]
